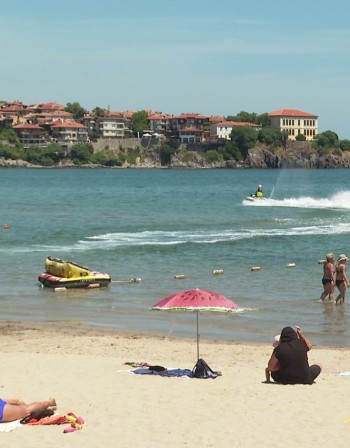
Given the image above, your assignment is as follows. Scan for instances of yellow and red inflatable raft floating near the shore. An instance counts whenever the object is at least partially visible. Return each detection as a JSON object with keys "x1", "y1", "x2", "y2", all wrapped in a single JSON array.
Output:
[{"x1": 38, "y1": 257, "x2": 111, "y2": 288}]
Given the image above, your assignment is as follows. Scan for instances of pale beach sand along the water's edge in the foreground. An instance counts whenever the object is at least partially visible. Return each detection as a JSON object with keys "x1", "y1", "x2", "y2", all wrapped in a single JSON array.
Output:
[{"x1": 0, "y1": 322, "x2": 350, "y2": 448}]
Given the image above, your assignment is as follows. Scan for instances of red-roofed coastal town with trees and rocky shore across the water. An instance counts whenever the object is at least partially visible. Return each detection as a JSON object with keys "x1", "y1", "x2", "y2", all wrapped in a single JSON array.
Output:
[{"x1": 0, "y1": 101, "x2": 350, "y2": 168}]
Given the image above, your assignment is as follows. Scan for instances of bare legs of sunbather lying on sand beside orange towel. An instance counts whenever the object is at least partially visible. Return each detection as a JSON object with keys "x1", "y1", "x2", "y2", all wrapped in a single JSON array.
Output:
[{"x1": 0, "y1": 398, "x2": 56, "y2": 423}]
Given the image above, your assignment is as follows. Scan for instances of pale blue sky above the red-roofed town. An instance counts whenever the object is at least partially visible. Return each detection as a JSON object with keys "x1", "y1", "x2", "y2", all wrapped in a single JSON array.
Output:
[{"x1": 0, "y1": 0, "x2": 350, "y2": 139}]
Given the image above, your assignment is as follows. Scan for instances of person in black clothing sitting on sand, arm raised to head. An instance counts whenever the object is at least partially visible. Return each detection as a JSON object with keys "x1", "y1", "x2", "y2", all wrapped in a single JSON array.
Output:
[{"x1": 267, "y1": 327, "x2": 322, "y2": 384}]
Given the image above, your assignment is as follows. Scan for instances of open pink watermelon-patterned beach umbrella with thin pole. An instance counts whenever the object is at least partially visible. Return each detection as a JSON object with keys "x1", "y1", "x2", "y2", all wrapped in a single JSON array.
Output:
[{"x1": 150, "y1": 289, "x2": 243, "y2": 359}]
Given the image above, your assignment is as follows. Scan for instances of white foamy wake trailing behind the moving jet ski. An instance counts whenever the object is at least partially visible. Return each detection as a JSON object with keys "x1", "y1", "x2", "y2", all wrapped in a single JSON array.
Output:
[{"x1": 242, "y1": 191, "x2": 350, "y2": 210}]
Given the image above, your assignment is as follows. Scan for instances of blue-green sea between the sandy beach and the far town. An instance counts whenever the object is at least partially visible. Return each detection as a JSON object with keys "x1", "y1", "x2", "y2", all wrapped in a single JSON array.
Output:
[{"x1": 0, "y1": 168, "x2": 350, "y2": 347}]
